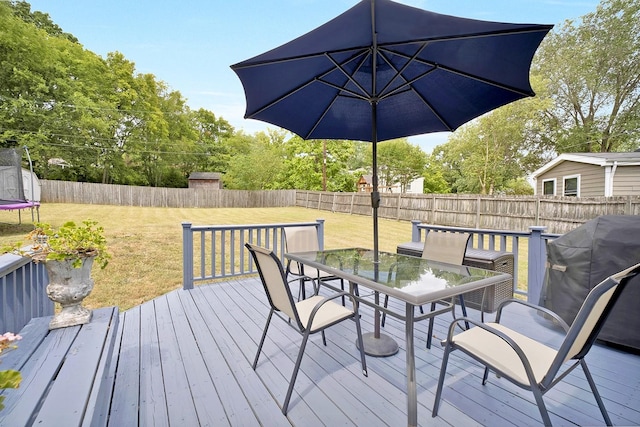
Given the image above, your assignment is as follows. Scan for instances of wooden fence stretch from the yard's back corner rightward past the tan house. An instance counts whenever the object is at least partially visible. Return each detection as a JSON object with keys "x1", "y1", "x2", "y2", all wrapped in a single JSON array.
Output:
[{"x1": 296, "y1": 190, "x2": 640, "y2": 234}]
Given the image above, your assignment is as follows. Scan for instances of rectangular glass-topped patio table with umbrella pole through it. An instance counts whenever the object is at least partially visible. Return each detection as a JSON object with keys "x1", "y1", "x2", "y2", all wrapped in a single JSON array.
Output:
[{"x1": 285, "y1": 248, "x2": 511, "y2": 426}]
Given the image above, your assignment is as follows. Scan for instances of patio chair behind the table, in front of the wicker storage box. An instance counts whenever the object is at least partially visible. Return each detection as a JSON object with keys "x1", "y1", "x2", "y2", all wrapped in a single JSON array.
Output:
[{"x1": 382, "y1": 231, "x2": 471, "y2": 348}]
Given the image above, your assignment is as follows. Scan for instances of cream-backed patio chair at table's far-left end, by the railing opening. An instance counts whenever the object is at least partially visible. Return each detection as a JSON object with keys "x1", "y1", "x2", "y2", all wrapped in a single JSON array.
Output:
[{"x1": 284, "y1": 225, "x2": 345, "y2": 305}]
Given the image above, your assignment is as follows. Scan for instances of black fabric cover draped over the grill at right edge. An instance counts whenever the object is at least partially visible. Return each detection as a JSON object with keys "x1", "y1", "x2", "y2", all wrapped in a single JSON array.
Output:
[{"x1": 540, "y1": 215, "x2": 640, "y2": 349}]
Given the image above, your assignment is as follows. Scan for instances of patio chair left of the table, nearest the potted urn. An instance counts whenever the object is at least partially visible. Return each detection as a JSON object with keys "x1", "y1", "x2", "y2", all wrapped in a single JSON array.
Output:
[{"x1": 245, "y1": 243, "x2": 368, "y2": 415}]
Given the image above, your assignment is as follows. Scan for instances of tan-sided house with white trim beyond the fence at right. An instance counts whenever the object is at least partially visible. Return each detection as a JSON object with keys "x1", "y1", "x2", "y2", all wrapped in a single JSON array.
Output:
[{"x1": 531, "y1": 151, "x2": 640, "y2": 197}]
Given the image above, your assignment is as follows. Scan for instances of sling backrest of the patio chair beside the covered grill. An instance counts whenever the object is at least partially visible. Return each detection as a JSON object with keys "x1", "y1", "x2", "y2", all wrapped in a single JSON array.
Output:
[{"x1": 545, "y1": 264, "x2": 640, "y2": 382}]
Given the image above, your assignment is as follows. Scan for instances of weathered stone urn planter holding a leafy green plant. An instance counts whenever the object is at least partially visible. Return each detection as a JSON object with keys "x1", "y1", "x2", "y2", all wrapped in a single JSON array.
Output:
[{"x1": 10, "y1": 220, "x2": 110, "y2": 329}]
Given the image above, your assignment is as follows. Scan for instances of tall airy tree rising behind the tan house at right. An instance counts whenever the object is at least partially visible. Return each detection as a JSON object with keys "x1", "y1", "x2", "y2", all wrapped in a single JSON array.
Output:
[{"x1": 539, "y1": 0, "x2": 640, "y2": 153}]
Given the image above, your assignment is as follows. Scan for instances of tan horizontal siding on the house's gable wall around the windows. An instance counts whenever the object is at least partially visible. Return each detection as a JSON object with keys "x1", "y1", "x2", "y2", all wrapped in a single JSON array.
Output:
[{"x1": 536, "y1": 161, "x2": 604, "y2": 197}]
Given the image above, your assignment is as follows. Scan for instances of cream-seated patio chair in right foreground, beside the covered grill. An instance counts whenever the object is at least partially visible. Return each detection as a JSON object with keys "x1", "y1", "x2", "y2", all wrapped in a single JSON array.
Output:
[{"x1": 432, "y1": 264, "x2": 640, "y2": 426}]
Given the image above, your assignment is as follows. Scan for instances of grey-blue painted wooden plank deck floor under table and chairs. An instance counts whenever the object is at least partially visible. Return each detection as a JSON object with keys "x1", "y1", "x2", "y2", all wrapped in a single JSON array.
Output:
[{"x1": 95, "y1": 278, "x2": 640, "y2": 426}]
